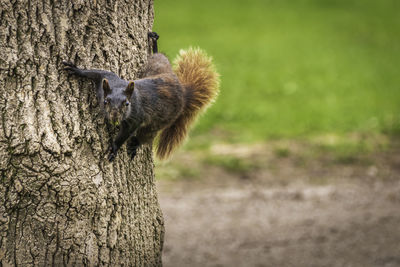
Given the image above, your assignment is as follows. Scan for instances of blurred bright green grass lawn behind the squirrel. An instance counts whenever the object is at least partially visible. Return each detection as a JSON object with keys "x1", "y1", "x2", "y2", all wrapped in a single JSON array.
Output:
[{"x1": 154, "y1": 0, "x2": 400, "y2": 148}]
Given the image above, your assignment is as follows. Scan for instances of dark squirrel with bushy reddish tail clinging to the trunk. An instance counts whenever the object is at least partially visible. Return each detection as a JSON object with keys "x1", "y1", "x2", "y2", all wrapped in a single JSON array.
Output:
[{"x1": 63, "y1": 32, "x2": 219, "y2": 162}]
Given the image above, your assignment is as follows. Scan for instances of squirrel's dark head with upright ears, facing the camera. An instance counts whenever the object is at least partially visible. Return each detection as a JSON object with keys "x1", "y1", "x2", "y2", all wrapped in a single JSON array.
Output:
[{"x1": 103, "y1": 79, "x2": 135, "y2": 126}]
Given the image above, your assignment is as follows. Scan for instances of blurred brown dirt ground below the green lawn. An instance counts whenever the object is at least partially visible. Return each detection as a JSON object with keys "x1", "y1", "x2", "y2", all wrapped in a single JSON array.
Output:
[{"x1": 158, "y1": 144, "x2": 400, "y2": 267}]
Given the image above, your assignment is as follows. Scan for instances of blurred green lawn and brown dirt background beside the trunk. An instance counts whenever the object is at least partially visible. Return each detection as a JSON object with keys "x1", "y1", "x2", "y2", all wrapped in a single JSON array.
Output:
[{"x1": 153, "y1": 0, "x2": 400, "y2": 266}]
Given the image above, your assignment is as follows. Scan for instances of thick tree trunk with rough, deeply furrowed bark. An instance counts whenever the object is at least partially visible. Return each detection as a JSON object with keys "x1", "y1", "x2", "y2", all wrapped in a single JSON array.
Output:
[{"x1": 0, "y1": 0, "x2": 164, "y2": 266}]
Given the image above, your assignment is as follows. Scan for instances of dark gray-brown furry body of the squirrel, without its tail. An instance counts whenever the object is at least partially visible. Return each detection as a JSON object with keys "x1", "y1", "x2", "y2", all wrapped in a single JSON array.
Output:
[{"x1": 64, "y1": 53, "x2": 184, "y2": 161}]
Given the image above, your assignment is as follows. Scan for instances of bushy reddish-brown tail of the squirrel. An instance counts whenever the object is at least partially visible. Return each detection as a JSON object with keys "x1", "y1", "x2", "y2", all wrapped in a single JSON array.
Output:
[{"x1": 157, "y1": 48, "x2": 219, "y2": 159}]
